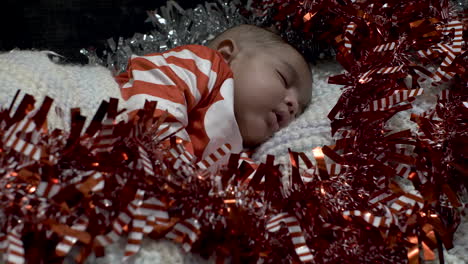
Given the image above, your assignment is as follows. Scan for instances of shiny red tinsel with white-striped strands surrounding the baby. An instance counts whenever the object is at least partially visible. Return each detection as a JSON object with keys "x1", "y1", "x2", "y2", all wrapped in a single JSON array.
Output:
[{"x1": 0, "y1": 0, "x2": 468, "y2": 263}]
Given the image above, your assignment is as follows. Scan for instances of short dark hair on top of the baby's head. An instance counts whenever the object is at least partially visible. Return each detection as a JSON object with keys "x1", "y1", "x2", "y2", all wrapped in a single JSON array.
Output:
[{"x1": 208, "y1": 25, "x2": 287, "y2": 49}]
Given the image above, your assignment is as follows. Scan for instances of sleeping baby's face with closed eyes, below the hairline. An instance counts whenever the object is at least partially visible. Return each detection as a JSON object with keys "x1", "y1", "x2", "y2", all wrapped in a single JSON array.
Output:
[{"x1": 230, "y1": 44, "x2": 312, "y2": 147}]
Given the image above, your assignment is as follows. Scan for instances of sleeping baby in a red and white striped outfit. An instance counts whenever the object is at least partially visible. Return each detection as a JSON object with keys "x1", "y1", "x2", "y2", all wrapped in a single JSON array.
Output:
[{"x1": 116, "y1": 25, "x2": 312, "y2": 165}]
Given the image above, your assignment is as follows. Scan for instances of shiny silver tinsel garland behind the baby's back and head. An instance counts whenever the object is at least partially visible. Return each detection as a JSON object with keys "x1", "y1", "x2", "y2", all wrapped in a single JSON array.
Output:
[{"x1": 80, "y1": 0, "x2": 251, "y2": 74}]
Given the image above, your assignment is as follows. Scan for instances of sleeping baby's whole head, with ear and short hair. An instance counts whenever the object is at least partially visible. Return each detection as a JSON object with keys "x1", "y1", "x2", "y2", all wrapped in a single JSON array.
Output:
[{"x1": 209, "y1": 25, "x2": 312, "y2": 147}]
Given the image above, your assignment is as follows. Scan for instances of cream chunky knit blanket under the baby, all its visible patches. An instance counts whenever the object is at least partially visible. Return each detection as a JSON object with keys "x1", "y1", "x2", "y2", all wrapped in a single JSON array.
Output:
[{"x1": 0, "y1": 51, "x2": 468, "y2": 264}]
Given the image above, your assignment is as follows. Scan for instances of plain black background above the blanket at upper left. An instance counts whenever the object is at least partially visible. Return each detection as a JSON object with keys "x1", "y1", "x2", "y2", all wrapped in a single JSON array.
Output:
[{"x1": 0, "y1": 0, "x2": 204, "y2": 62}]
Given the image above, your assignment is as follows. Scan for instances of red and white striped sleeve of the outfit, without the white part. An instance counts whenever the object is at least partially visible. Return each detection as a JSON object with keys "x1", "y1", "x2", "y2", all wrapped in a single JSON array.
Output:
[{"x1": 116, "y1": 45, "x2": 232, "y2": 157}]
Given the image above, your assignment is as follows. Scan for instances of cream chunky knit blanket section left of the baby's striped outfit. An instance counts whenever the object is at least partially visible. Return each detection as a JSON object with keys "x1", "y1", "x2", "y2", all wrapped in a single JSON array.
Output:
[{"x1": 0, "y1": 51, "x2": 121, "y2": 129}]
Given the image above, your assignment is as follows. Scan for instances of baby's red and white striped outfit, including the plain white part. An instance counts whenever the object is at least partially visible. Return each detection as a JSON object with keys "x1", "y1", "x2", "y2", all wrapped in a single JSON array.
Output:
[{"x1": 116, "y1": 45, "x2": 242, "y2": 166}]
